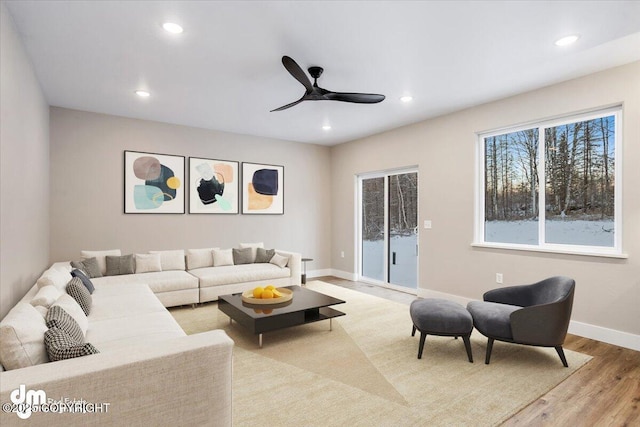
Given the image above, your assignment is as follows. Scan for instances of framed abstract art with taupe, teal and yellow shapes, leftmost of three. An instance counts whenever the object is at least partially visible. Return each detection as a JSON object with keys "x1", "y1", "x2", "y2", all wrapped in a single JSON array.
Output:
[{"x1": 124, "y1": 150, "x2": 185, "y2": 214}]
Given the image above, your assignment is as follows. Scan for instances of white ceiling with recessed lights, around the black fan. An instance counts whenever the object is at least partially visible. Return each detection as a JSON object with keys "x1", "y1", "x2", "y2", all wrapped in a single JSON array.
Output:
[{"x1": 4, "y1": 1, "x2": 640, "y2": 145}]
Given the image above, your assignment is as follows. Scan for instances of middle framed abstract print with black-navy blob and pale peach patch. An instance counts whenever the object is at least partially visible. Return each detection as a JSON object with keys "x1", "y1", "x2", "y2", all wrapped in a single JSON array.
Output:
[{"x1": 189, "y1": 157, "x2": 240, "y2": 215}]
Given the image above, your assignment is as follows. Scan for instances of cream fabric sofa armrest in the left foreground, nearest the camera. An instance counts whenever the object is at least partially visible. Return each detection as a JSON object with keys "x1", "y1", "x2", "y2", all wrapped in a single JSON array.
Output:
[{"x1": 0, "y1": 330, "x2": 233, "y2": 426}]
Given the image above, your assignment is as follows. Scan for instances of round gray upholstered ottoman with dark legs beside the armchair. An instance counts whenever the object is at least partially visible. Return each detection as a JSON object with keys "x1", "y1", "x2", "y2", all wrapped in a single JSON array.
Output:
[{"x1": 409, "y1": 298, "x2": 473, "y2": 363}]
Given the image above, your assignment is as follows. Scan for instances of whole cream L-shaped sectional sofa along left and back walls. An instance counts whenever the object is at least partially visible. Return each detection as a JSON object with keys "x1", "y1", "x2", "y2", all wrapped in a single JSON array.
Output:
[{"x1": 0, "y1": 244, "x2": 301, "y2": 426}]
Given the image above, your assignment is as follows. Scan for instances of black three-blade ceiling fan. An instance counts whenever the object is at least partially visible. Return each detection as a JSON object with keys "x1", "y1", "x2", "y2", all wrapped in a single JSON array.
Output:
[{"x1": 271, "y1": 56, "x2": 384, "y2": 112}]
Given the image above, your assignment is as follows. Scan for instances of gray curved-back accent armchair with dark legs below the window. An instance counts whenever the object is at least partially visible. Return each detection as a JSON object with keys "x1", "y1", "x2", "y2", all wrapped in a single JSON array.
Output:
[{"x1": 467, "y1": 276, "x2": 575, "y2": 367}]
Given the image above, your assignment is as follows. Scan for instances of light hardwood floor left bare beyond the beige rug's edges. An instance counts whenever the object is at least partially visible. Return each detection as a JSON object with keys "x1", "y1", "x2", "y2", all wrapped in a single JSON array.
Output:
[{"x1": 315, "y1": 276, "x2": 640, "y2": 427}]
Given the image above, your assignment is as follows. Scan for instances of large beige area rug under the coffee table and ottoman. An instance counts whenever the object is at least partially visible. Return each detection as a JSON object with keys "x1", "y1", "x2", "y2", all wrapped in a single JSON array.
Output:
[{"x1": 171, "y1": 281, "x2": 590, "y2": 426}]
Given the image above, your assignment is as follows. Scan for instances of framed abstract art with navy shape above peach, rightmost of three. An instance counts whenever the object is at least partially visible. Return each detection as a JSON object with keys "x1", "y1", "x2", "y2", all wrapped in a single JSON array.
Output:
[{"x1": 242, "y1": 162, "x2": 284, "y2": 215}]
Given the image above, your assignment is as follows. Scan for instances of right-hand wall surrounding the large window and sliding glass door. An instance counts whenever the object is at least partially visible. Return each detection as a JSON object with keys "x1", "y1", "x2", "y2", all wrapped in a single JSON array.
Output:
[{"x1": 331, "y1": 62, "x2": 640, "y2": 345}]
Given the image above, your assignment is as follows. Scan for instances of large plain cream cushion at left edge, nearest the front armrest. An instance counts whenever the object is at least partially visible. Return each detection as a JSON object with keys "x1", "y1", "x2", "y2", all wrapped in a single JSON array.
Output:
[{"x1": 0, "y1": 302, "x2": 49, "y2": 370}]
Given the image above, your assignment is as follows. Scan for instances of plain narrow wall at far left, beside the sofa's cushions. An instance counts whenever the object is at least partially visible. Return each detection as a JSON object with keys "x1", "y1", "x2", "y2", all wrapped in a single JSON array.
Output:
[{"x1": 0, "y1": 3, "x2": 49, "y2": 318}]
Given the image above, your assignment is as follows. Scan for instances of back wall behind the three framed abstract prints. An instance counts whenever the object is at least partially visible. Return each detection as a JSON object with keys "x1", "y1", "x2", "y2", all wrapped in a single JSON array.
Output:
[{"x1": 50, "y1": 107, "x2": 331, "y2": 269}]
